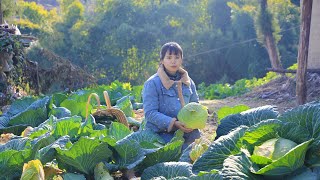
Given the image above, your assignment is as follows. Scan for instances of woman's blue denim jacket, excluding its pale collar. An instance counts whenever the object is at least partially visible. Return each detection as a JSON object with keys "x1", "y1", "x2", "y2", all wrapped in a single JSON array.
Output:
[{"x1": 142, "y1": 69, "x2": 199, "y2": 132}]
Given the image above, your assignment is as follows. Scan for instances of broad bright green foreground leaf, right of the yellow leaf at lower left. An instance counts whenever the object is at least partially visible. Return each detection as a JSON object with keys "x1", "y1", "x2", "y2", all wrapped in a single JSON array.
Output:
[{"x1": 56, "y1": 137, "x2": 112, "y2": 174}]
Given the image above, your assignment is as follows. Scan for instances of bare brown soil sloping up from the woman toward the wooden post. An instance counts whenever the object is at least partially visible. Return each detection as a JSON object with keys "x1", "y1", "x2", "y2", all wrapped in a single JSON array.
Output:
[{"x1": 200, "y1": 73, "x2": 320, "y2": 140}]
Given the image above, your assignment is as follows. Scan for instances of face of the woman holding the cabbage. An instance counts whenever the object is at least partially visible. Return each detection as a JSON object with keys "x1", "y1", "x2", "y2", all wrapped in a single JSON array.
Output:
[{"x1": 161, "y1": 51, "x2": 182, "y2": 75}]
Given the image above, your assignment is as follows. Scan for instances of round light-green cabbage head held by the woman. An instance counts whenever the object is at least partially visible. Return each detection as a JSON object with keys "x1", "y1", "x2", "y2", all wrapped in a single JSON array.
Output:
[{"x1": 178, "y1": 102, "x2": 208, "y2": 129}]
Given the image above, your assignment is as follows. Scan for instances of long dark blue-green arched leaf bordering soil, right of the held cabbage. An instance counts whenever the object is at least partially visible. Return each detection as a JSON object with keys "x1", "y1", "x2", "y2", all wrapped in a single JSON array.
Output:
[{"x1": 216, "y1": 105, "x2": 278, "y2": 138}]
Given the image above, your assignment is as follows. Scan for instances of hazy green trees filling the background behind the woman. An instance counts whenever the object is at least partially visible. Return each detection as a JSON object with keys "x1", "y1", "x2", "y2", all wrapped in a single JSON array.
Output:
[{"x1": 6, "y1": 0, "x2": 299, "y2": 95}]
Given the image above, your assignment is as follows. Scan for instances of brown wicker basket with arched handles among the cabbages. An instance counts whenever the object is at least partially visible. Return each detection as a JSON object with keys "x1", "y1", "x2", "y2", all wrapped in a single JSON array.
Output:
[{"x1": 86, "y1": 91, "x2": 129, "y2": 127}]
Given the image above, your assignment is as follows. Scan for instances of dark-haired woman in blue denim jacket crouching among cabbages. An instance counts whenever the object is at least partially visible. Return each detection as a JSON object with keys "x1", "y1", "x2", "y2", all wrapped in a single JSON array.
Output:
[{"x1": 142, "y1": 42, "x2": 200, "y2": 149}]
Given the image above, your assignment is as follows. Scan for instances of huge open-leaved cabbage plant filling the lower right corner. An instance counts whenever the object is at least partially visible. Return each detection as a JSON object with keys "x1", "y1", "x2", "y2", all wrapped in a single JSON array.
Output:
[{"x1": 142, "y1": 102, "x2": 320, "y2": 180}]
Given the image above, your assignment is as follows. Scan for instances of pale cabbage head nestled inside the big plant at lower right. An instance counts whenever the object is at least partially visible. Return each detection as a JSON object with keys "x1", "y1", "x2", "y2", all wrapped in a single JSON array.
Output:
[{"x1": 253, "y1": 138, "x2": 297, "y2": 160}]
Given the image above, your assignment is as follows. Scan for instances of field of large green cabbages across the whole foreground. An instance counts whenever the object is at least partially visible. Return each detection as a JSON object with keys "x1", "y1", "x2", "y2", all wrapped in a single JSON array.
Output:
[{"x1": 0, "y1": 82, "x2": 320, "y2": 180}]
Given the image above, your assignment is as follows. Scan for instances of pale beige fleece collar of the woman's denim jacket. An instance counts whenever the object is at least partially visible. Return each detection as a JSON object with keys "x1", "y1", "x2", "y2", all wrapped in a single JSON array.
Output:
[{"x1": 157, "y1": 65, "x2": 191, "y2": 89}]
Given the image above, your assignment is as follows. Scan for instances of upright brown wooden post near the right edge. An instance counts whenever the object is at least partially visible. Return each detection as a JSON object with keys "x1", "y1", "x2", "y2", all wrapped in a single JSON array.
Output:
[{"x1": 296, "y1": 0, "x2": 313, "y2": 105}]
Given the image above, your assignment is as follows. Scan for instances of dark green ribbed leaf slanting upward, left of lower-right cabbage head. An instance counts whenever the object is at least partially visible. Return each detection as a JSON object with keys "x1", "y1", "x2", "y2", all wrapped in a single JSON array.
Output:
[{"x1": 193, "y1": 126, "x2": 248, "y2": 173}]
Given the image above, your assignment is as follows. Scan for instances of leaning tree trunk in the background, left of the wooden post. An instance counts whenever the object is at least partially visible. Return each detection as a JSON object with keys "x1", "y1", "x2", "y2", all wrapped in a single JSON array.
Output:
[{"x1": 260, "y1": 0, "x2": 282, "y2": 69}]
